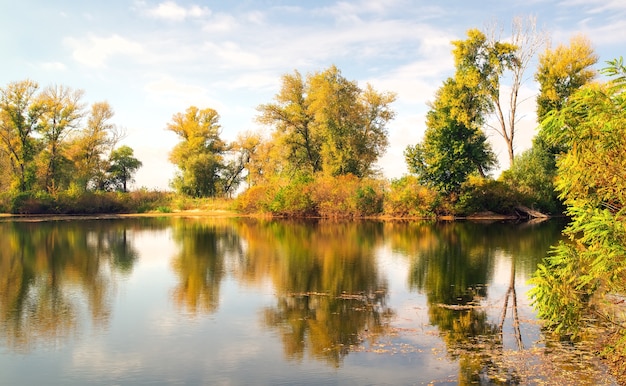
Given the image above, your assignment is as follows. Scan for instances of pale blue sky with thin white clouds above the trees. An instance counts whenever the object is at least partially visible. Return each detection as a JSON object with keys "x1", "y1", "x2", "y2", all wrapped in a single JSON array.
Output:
[{"x1": 0, "y1": 0, "x2": 626, "y2": 190}]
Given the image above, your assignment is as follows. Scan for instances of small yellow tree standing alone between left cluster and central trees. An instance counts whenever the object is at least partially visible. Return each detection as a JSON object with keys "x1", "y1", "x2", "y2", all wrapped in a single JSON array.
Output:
[{"x1": 167, "y1": 106, "x2": 226, "y2": 197}]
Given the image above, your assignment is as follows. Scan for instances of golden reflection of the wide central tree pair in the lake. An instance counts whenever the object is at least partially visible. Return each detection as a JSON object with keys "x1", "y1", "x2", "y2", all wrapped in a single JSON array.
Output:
[{"x1": 247, "y1": 222, "x2": 392, "y2": 366}]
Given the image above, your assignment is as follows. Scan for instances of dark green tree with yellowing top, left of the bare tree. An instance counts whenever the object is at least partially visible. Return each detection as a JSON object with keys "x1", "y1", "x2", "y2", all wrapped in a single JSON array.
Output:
[{"x1": 404, "y1": 78, "x2": 496, "y2": 193}]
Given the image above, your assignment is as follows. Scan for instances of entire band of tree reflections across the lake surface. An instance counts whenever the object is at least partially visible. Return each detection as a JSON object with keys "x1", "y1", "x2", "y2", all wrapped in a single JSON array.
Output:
[{"x1": 0, "y1": 218, "x2": 572, "y2": 383}]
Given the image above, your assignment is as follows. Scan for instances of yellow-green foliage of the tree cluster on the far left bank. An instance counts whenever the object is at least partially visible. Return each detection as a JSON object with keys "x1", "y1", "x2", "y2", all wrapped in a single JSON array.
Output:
[{"x1": 0, "y1": 80, "x2": 141, "y2": 201}]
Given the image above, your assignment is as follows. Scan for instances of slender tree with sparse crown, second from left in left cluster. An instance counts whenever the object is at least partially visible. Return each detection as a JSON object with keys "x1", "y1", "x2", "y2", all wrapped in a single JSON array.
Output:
[{"x1": 38, "y1": 86, "x2": 83, "y2": 192}]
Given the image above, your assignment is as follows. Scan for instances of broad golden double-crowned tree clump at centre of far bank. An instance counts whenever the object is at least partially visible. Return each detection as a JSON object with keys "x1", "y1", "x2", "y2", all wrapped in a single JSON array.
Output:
[{"x1": 258, "y1": 66, "x2": 395, "y2": 177}]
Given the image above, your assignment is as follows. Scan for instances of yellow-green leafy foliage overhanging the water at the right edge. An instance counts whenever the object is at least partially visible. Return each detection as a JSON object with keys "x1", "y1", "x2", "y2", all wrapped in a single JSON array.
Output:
[{"x1": 532, "y1": 59, "x2": 626, "y2": 344}]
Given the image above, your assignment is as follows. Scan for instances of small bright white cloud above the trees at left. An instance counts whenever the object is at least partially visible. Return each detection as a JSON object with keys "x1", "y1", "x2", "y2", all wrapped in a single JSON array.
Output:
[{"x1": 64, "y1": 34, "x2": 143, "y2": 67}]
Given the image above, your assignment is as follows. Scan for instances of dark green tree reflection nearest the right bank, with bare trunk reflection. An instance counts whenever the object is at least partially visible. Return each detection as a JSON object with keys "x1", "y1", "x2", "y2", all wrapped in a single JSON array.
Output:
[{"x1": 392, "y1": 222, "x2": 560, "y2": 384}]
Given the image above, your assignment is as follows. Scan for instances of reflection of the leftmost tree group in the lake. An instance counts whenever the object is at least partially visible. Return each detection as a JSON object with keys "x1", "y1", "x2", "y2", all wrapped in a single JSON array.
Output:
[{"x1": 0, "y1": 221, "x2": 142, "y2": 352}]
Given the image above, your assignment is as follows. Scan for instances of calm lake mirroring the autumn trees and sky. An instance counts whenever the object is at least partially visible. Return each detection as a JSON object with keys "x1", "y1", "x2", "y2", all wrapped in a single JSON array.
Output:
[{"x1": 0, "y1": 217, "x2": 612, "y2": 385}]
